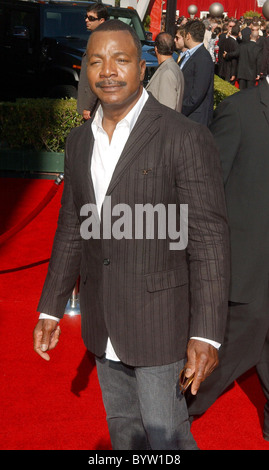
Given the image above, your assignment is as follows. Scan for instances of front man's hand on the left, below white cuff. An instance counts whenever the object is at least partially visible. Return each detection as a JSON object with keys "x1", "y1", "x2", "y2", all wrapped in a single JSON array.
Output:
[{"x1": 33, "y1": 319, "x2": 61, "y2": 361}]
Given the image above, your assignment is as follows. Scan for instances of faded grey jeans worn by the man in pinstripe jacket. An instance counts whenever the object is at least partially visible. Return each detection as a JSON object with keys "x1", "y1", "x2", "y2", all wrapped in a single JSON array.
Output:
[{"x1": 96, "y1": 358, "x2": 198, "y2": 450}]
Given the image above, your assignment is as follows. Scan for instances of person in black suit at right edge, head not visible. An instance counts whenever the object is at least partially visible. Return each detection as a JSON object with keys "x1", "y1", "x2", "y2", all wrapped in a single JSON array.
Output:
[{"x1": 188, "y1": 71, "x2": 269, "y2": 441}]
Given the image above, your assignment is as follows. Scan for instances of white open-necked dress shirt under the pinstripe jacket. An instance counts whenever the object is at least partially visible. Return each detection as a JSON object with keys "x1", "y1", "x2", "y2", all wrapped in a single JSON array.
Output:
[{"x1": 39, "y1": 89, "x2": 220, "y2": 361}]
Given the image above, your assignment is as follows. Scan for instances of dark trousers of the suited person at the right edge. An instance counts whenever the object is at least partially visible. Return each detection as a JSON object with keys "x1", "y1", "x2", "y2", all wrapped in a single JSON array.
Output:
[{"x1": 188, "y1": 282, "x2": 269, "y2": 435}]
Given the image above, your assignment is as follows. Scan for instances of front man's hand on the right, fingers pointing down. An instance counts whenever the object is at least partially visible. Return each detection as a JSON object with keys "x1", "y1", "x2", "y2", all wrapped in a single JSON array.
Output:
[{"x1": 185, "y1": 339, "x2": 218, "y2": 395}]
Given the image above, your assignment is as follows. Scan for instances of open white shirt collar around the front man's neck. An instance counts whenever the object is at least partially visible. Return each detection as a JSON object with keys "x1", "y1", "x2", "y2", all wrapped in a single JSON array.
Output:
[{"x1": 91, "y1": 88, "x2": 149, "y2": 138}]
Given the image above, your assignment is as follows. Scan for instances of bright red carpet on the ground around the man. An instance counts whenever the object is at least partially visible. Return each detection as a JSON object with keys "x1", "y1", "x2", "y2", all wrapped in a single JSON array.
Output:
[{"x1": 0, "y1": 178, "x2": 269, "y2": 450}]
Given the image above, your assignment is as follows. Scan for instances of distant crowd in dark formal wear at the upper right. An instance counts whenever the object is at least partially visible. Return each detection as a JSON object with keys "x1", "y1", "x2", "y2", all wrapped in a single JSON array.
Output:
[{"x1": 174, "y1": 17, "x2": 269, "y2": 89}]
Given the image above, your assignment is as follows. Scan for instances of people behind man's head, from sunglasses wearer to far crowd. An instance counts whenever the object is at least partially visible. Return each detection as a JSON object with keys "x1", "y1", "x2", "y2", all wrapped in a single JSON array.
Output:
[{"x1": 77, "y1": 5, "x2": 269, "y2": 129}]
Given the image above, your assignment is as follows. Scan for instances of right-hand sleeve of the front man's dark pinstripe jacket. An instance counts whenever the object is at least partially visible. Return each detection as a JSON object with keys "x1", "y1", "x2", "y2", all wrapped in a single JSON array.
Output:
[{"x1": 176, "y1": 121, "x2": 230, "y2": 343}]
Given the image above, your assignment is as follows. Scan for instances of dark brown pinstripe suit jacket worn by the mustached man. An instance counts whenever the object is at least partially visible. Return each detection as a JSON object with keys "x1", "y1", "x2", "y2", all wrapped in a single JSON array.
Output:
[{"x1": 38, "y1": 96, "x2": 229, "y2": 366}]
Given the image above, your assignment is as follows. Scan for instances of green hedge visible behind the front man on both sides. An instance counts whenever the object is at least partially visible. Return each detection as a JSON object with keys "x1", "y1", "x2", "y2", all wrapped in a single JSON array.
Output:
[{"x1": 0, "y1": 76, "x2": 238, "y2": 152}]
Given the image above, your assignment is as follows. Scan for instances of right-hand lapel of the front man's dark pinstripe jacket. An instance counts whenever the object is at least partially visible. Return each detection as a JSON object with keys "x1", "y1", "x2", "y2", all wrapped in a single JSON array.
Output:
[{"x1": 107, "y1": 95, "x2": 161, "y2": 195}]
